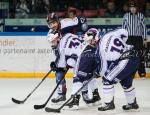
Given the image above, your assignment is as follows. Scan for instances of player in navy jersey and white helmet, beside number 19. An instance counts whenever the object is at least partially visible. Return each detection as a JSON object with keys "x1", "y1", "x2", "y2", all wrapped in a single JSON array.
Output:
[{"x1": 67, "y1": 28, "x2": 100, "y2": 109}]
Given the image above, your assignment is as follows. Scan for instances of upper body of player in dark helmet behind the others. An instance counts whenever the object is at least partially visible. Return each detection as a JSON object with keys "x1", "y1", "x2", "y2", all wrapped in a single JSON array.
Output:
[{"x1": 47, "y1": 10, "x2": 88, "y2": 36}]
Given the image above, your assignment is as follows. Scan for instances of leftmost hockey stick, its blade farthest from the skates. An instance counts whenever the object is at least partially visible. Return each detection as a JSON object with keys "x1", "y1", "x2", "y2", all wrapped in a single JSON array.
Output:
[{"x1": 12, "y1": 70, "x2": 52, "y2": 104}]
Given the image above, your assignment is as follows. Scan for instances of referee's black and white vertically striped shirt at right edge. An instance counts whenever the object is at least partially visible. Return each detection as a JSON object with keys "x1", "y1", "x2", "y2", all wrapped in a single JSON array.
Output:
[{"x1": 122, "y1": 12, "x2": 147, "y2": 39}]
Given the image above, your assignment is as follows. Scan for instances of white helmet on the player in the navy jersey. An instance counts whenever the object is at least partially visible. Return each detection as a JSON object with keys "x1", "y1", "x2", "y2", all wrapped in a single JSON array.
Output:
[{"x1": 83, "y1": 28, "x2": 100, "y2": 42}]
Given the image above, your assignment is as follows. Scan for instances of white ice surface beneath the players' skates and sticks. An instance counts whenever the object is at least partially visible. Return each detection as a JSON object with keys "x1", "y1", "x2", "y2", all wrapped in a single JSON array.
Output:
[{"x1": 0, "y1": 78, "x2": 150, "y2": 115}]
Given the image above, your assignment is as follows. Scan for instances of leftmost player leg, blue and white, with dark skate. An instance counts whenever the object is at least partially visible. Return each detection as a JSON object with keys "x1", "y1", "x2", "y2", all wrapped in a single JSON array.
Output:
[{"x1": 51, "y1": 68, "x2": 67, "y2": 103}]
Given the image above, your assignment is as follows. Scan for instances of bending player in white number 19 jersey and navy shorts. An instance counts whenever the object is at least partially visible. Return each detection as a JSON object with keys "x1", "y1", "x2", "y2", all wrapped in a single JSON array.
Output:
[{"x1": 98, "y1": 29, "x2": 139, "y2": 111}]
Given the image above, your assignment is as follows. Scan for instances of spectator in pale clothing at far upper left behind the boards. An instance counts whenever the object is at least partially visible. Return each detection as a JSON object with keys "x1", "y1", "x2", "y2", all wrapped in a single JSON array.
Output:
[{"x1": 16, "y1": 0, "x2": 30, "y2": 18}]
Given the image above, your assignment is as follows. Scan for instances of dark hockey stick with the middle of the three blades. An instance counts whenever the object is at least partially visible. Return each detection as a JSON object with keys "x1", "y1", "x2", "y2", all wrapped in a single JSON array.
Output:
[{"x1": 34, "y1": 70, "x2": 68, "y2": 109}]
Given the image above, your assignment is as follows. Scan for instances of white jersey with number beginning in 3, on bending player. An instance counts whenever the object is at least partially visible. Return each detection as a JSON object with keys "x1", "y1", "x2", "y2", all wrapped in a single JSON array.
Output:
[{"x1": 56, "y1": 33, "x2": 87, "y2": 68}]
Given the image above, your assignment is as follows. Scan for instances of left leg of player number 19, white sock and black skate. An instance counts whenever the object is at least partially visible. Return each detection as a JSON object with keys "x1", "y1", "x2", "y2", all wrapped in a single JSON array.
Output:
[{"x1": 98, "y1": 60, "x2": 128, "y2": 111}]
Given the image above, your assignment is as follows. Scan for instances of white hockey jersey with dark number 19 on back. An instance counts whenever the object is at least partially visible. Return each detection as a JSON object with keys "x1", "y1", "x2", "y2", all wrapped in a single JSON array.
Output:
[{"x1": 98, "y1": 29, "x2": 131, "y2": 75}]
